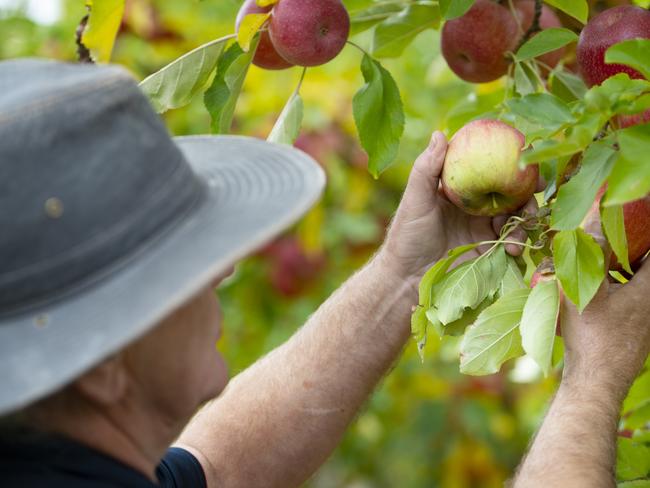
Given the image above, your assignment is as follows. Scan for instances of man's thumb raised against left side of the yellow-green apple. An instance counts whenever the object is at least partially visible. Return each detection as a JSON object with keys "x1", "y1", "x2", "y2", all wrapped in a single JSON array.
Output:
[{"x1": 403, "y1": 131, "x2": 447, "y2": 207}]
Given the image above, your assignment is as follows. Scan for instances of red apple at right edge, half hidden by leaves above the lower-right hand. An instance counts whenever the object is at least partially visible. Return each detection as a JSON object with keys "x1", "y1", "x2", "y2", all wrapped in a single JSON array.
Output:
[{"x1": 584, "y1": 185, "x2": 650, "y2": 271}]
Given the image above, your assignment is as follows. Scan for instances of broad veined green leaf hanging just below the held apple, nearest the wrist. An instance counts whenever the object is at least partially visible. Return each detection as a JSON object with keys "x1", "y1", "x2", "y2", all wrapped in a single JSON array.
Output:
[{"x1": 432, "y1": 246, "x2": 507, "y2": 324}]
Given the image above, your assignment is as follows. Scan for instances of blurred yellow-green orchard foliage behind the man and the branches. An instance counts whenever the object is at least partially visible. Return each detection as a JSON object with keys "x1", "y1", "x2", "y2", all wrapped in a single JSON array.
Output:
[{"x1": 0, "y1": 0, "x2": 650, "y2": 488}]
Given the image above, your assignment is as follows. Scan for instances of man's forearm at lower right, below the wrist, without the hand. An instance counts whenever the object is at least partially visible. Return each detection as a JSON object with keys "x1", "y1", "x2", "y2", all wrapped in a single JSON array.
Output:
[{"x1": 514, "y1": 374, "x2": 624, "y2": 488}]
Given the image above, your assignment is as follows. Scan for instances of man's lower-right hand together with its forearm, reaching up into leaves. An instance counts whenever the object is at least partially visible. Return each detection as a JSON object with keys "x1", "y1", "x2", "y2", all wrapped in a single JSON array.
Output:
[{"x1": 515, "y1": 260, "x2": 650, "y2": 488}]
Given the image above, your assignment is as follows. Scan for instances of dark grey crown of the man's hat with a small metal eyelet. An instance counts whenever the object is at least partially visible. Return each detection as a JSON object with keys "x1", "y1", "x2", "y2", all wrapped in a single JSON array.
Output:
[{"x1": 0, "y1": 60, "x2": 204, "y2": 315}]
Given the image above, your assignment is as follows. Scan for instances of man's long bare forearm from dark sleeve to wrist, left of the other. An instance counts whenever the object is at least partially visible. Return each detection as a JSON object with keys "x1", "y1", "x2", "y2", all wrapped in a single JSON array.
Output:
[{"x1": 181, "y1": 255, "x2": 417, "y2": 487}]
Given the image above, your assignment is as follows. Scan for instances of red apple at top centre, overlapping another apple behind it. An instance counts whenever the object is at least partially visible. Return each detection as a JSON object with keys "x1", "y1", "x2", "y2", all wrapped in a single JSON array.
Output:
[{"x1": 269, "y1": 0, "x2": 350, "y2": 66}]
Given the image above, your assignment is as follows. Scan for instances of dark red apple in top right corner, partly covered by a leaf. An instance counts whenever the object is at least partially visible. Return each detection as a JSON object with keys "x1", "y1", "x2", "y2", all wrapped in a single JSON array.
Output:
[{"x1": 576, "y1": 5, "x2": 650, "y2": 86}]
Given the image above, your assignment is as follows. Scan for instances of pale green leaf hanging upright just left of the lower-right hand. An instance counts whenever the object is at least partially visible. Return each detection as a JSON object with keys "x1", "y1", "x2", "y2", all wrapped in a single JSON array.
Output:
[{"x1": 519, "y1": 280, "x2": 560, "y2": 376}]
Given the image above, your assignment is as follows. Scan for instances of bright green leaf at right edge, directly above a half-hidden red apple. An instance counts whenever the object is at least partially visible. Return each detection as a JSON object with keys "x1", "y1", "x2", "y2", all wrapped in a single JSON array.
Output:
[{"x1": 604, "y1": 124, "x2": 650, "y2": 206}]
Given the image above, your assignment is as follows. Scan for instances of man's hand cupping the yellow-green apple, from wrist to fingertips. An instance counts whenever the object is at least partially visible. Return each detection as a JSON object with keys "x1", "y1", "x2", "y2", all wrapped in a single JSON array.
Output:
[{"x1": 381, "y1": 132, "x2": 537, "y2": 283}]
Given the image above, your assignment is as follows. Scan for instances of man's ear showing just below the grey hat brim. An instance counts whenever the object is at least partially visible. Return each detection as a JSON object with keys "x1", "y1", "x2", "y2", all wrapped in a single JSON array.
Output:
[{"x1": 73, "y1": 353, "x2": 128, "y2": 406}]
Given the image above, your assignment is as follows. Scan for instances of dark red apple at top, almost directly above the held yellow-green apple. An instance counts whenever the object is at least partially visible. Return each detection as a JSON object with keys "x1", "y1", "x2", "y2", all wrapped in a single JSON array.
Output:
[{"x1": 441, "y1": 0, "x2": 520, "y2": 83}]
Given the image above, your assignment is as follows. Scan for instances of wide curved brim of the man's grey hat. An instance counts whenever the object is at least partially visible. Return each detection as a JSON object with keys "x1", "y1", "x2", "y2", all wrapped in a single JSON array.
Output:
[{"x1": 0, "y1": 136, "x2": 325, "y2": 414}]
